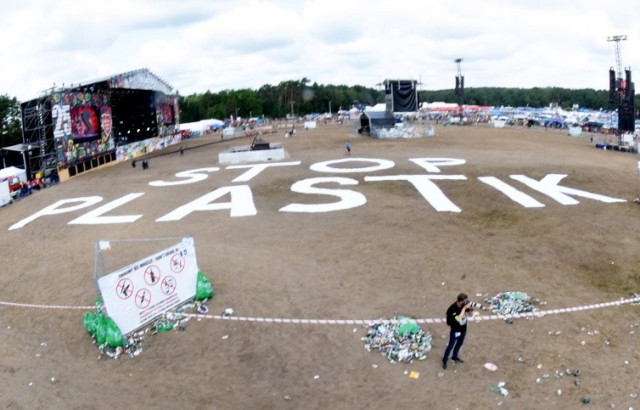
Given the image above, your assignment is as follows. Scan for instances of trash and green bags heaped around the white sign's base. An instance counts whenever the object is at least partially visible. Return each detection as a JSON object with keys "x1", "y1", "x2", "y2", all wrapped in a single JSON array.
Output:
[{"x1": 84, "y1": 272, "x2": 215, "y2": 359}]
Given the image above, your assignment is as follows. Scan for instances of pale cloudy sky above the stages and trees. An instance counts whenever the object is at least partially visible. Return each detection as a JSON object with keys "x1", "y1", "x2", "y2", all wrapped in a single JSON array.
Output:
[{"x1": 0, "y1": 0, "x2": 640, "y2": 101}]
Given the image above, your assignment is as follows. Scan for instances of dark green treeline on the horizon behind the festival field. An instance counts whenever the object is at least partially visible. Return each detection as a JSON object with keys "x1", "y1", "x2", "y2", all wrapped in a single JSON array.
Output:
[{"x1": 179, "y1": 78, "x2": 640, "y2": 122}]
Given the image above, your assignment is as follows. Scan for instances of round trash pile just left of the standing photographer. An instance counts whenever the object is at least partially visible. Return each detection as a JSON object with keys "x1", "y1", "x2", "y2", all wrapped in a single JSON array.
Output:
[{"x1": 362, "y1": 316, "x2": 432, "y2": 363}]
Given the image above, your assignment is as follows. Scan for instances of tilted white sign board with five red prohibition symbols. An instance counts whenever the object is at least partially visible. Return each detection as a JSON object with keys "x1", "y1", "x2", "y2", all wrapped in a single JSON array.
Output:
[{"x1": 98, "y1": 238, "x2": 198, "y2": 335}]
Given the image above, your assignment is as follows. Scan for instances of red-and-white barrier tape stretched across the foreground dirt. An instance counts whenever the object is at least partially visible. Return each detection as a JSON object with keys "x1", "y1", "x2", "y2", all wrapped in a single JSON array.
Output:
[{"x1": 0, "y1": 295, "x2": 640, "y2": 325}]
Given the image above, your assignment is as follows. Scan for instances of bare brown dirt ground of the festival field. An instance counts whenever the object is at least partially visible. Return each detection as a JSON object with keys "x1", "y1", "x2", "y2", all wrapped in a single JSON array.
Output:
[{"x1": 0, "y1": 125, "x2": 640, "y2": 409}]
